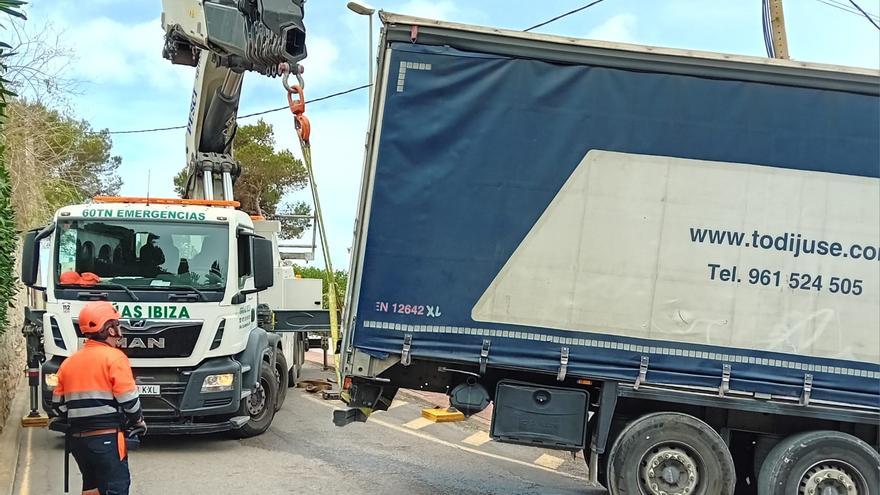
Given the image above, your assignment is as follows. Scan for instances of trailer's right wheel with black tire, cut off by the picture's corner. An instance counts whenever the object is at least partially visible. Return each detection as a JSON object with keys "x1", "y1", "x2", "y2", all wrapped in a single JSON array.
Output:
[{"x1": 758, "y1": 431, "x2": 880, "y2": 495}]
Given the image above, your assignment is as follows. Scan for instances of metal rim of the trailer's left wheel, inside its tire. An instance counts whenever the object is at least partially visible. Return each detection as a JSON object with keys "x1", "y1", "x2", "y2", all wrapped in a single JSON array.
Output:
[{"x1": 640, "y1": 444, "x2": 701, "y2": 495}]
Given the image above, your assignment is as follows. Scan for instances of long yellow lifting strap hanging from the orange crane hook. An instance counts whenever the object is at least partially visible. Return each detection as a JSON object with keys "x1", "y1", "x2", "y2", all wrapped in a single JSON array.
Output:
[{"x1": 280, "y1": 64, "x2": 342, "y2": 387}]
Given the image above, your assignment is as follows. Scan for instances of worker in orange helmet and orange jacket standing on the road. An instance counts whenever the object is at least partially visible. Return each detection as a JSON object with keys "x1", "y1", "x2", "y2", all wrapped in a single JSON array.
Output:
[{"x1": 52, "y1": 301, "x2": 146, "y2": 495}]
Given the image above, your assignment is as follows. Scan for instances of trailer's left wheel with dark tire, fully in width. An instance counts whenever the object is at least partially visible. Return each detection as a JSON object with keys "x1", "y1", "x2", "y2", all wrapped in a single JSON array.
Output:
[{"x1": 606, "y1": 412, "x2": 736, "y2": 495}]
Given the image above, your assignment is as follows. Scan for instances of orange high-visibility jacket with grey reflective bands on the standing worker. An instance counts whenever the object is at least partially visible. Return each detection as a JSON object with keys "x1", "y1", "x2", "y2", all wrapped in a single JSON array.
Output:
[{"x1": 52, "y1": 340, "x2": 143, "y2": 431}]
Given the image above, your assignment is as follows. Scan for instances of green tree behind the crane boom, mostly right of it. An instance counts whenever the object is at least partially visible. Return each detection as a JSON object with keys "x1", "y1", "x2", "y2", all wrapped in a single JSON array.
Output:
[{"x1": 174, "y1": 119, "x2": 311, "y2": 239}]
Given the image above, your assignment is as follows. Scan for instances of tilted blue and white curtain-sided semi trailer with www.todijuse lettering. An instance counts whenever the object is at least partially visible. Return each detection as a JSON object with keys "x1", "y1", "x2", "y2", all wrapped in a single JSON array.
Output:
[{"x1": 334, "y1": 13, "x2": 880, "y2": 495}]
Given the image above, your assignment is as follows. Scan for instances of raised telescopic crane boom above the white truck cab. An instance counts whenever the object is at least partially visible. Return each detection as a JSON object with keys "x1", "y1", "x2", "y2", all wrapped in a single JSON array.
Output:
[{"x1": 162, "y1": 0, "x2": 306, "y2": 200}]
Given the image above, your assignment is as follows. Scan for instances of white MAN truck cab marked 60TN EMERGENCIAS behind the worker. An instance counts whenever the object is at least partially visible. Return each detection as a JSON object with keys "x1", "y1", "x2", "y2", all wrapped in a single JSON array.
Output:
[{"x1": 22, "y1": 198, "x2": 321, "y2": 436}]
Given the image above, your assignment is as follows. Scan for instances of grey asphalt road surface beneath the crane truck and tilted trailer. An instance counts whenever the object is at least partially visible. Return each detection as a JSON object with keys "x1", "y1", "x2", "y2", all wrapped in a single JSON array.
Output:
[{"x1": 13, "y1": 364, "x2": 605, "y2": 495}]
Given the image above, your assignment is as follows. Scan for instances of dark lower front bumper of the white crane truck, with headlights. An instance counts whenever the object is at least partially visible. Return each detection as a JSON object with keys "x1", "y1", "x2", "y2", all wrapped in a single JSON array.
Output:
[{"x1": 41, "y1": 357, "x2": 246, "y2": 434}]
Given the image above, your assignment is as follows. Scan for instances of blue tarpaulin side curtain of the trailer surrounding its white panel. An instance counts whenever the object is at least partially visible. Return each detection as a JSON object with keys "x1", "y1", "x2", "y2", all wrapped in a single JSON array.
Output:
[{"x1": 344, "y1": 16, "x2": 880, "y2": 414}]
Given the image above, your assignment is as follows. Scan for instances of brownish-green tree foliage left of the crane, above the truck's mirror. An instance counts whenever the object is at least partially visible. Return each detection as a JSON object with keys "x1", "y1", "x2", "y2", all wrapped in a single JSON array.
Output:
[{"x1": 4, "y1": 99, "x2": 122, "y2": 229}]
